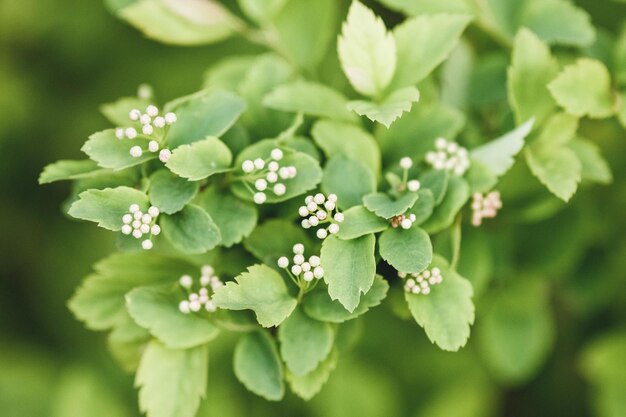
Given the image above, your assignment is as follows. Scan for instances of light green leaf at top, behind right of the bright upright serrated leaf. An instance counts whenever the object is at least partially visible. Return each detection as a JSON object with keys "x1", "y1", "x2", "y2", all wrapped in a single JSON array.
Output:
[{"x1": 391, "y1": 14, "x2": 470, "y2": 89}]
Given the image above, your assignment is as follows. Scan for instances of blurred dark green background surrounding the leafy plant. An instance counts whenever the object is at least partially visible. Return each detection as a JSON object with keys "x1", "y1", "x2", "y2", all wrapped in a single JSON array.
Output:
[{"x1": 0, "y1": 0, "x2": 626, "y2": 417}]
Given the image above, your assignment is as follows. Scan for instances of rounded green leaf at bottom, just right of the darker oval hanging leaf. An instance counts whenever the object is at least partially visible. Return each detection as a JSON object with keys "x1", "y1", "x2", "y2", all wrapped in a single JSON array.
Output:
[{"x1": 278, "y1": 308, "x2": 334, "y2": 376}]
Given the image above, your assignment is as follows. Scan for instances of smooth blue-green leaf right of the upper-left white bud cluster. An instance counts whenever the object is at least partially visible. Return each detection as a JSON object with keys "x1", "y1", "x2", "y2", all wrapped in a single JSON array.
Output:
[{"x1": 167, "y1": 91, "x2": 246, "y2": 148}]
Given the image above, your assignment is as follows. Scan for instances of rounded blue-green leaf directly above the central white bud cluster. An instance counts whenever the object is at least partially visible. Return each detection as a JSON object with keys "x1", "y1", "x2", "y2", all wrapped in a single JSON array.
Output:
[{"x1": 322, "y1": 155, "x2": 376, "y2": 209}]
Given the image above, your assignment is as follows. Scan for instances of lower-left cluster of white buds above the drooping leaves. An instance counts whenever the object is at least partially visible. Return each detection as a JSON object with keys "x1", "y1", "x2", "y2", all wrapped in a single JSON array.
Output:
[{"x1": 178, "y1": 265, "x2": 224, "y2": 314}]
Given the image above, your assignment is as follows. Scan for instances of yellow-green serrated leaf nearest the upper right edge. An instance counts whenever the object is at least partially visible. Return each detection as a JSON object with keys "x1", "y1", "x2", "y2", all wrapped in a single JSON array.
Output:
[{"x1": 548, "y1": 58, "x2": 615, "y2": 119}]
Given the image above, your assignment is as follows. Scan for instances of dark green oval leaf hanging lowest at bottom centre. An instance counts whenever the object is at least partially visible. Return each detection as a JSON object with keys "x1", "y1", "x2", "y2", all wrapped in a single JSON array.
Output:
[{"x1": 233, "y1": 331, "x2": 285, "y2": 401}]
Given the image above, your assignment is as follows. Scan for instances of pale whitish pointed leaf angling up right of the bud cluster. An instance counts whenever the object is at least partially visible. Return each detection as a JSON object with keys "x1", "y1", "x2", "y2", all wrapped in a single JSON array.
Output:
[{"x1": 470, "y1": 119, "x2": 533, "y2": 176}]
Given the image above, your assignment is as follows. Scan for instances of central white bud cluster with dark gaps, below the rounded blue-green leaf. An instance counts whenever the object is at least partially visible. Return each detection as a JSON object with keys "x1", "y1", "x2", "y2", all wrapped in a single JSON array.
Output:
[{"x1": 298, "y1": 193, "x2": 343, "y2": 239}]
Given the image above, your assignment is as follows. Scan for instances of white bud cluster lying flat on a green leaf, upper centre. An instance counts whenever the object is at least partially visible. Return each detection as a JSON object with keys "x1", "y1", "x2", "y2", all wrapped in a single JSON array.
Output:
[{"x1": 241, "y1": 148, "x2": 298, "y2": 204}]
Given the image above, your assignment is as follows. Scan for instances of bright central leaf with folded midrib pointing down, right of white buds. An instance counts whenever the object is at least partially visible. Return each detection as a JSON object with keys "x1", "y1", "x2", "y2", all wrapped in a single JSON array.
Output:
[{"x1": 321, "y1": 235, "x2": 376, "y2": 312}]
